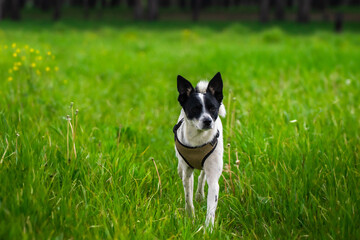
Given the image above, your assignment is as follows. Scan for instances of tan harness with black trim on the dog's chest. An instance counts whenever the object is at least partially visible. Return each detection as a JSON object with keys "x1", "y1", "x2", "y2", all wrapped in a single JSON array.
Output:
[{"x1": 173, "y1": 118, "x2": 220, "y2": 170}]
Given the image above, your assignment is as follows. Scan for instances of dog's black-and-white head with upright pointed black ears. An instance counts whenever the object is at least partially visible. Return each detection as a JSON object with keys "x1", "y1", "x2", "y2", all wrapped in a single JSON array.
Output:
[{"x1": 177, "y1": 73, "x2": 223, "y2": 130}]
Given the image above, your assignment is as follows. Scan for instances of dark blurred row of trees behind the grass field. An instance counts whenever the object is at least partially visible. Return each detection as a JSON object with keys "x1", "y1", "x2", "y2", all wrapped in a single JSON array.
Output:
[{"x1": 0, "y1": 0, "x2": 360, "y2": 22}]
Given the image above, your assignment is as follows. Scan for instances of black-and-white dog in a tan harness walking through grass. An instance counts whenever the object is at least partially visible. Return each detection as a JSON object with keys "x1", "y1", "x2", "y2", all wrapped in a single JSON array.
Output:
[{"x1": 173, "y1": 73, "x2": 226, "y2": 231}]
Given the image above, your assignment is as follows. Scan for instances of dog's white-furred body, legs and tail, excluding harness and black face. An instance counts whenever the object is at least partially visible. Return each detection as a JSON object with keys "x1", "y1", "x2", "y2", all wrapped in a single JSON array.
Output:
[{"x1": 175, "y1": 81, "x2": 226, "y2": 228}]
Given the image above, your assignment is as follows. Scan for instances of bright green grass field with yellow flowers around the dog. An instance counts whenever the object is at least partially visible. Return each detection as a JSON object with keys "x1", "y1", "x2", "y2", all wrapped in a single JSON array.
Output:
[{"x1": 0, "y1": 21, "x2": 360, "y2": 239}]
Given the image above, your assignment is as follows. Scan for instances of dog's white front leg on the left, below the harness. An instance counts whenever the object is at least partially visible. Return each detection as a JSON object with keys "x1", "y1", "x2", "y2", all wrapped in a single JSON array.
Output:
[{"x1": 183, "y1": 167, "x2": 195, "y2": 217}]
